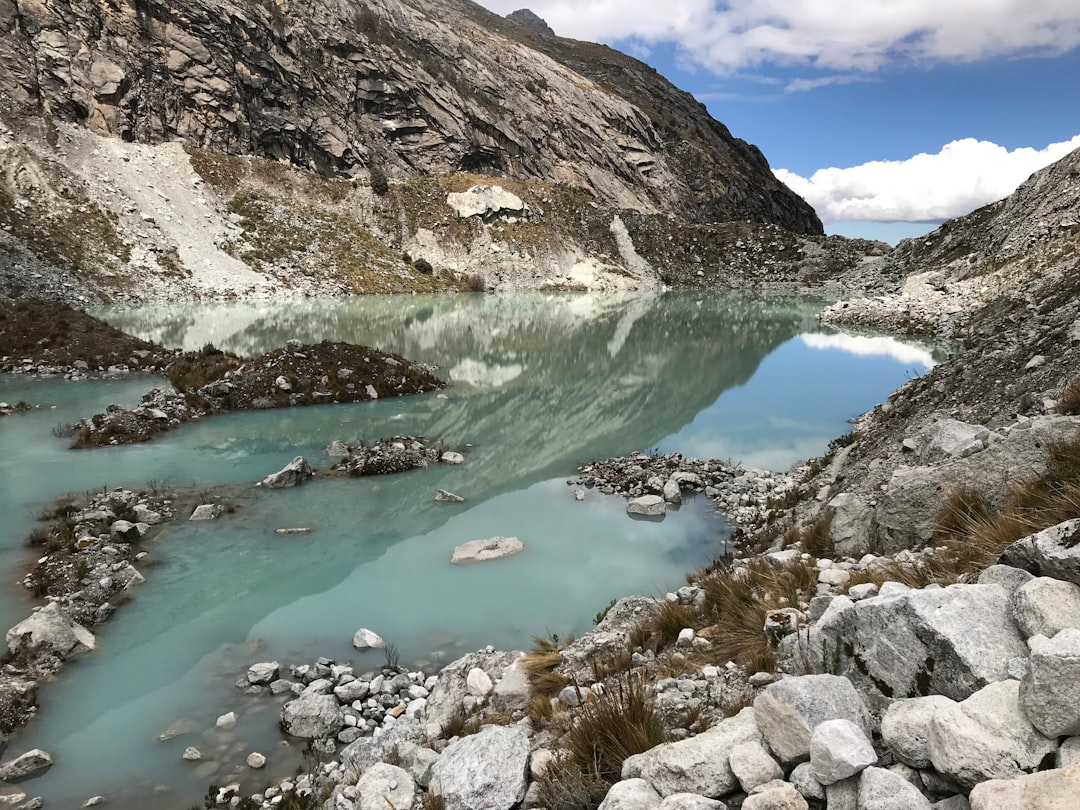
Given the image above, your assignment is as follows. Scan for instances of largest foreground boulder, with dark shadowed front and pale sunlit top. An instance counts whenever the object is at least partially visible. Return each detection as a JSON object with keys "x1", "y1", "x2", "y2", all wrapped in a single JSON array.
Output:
[{"x1": 808, "y1": 585, "x2": 1027, "y2": 707}]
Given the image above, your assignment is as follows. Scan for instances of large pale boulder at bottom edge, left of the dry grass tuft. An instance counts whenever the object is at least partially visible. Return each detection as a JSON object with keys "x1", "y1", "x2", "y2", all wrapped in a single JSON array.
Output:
[{"x1": 431, "y1": 726, "x2": 529, "y2": 810}]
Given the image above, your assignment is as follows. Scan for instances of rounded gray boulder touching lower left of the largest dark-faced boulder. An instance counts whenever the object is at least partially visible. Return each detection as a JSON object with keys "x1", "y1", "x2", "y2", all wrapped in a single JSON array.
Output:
[{"x1": 754, "y1": 675, "x2": 870, "y2": 764}]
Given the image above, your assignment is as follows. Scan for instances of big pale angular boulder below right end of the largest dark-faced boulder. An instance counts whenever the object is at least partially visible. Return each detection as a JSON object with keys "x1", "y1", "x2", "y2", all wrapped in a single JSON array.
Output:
[{"x1": 928, "y1": 680, "x2": 1057, "y2": 788}]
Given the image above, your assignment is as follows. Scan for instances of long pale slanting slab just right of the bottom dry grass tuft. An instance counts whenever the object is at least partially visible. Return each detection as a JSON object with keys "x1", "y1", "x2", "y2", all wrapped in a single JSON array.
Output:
[{"x1": 622, "y1": 708, "x2": 761, "y2": 798}]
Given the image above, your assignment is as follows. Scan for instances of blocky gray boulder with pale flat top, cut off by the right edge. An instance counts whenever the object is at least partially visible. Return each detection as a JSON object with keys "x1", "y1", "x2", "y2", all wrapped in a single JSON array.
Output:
[{"x1": 1020, "y1": 629, "x2": 1080, "y2": 738}]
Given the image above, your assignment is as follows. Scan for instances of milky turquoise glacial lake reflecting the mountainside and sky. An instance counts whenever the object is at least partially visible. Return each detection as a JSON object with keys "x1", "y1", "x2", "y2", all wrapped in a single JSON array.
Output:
[{"x1": 0, "y1": 293, "x2": 941, "y2": 810}]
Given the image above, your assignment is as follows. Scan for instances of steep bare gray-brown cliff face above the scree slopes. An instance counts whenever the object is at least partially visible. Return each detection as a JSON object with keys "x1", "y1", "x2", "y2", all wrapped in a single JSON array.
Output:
[{"x1": 0, "y1": 0, "x2": 821, "y2": 233}]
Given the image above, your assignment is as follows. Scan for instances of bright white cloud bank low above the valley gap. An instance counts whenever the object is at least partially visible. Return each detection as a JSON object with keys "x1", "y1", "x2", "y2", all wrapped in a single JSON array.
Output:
[{"x1": 773, "y1": 135, "x2": 1080, "y2": 222}]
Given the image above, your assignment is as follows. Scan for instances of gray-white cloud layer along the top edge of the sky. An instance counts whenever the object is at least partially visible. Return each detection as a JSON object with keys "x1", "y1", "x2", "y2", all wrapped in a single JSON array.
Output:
[{"x1": 481, "y1": 0, "x2": 1080, "y2": 72}]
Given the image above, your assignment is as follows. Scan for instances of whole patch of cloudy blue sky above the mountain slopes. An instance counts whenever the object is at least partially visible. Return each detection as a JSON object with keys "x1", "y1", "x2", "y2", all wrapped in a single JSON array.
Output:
[{"x1": 482, "y1": 0, "x2": 1080, "y2": 242}]
